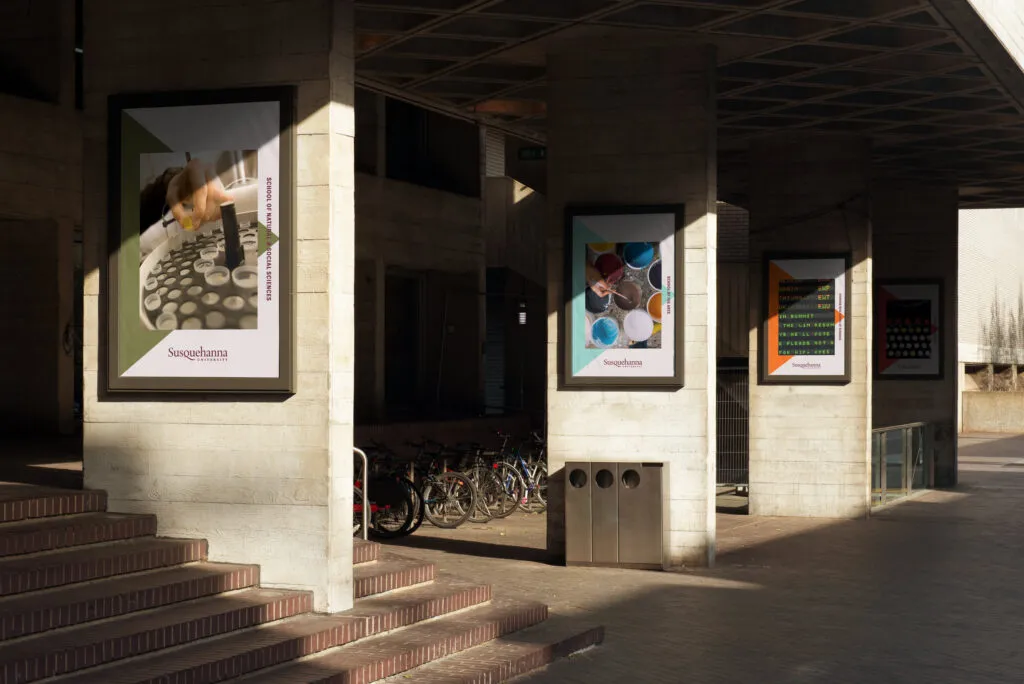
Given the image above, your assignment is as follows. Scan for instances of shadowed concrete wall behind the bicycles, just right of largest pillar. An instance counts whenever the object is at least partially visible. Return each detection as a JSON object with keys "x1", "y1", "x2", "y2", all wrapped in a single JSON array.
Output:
[{"x1": 355, "y1": 173, "x2": 486, "y2": 421}]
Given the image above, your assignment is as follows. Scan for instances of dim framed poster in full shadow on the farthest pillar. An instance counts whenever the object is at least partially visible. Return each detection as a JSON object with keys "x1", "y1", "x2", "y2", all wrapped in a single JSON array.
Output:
[{"x1": 874, "y1": 280, "x2": 943, "y2": 380}]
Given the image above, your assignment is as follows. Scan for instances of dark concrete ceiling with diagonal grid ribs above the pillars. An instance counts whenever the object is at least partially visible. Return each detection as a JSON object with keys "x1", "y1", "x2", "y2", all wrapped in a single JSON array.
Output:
[{"x1": 355, "y1": 0, "x2": 1024, "y2": 207}]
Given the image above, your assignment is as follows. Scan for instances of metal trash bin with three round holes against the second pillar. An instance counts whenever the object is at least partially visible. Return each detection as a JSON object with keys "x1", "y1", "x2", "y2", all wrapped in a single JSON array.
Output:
[{"x1": 565, "y1": 462, "x2": 669, "y2": 569}]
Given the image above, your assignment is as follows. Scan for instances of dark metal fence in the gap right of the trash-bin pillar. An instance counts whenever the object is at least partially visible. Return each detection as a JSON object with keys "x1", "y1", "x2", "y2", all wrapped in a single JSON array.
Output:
[{"x1": 716, "y1": 359, "x2": 751, "y2": 486}]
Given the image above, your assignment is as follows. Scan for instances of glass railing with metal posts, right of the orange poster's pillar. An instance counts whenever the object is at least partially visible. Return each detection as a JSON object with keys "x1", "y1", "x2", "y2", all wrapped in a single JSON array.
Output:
[{"x1": 871, "y1": 423, "x2": 932, "y2": 505}]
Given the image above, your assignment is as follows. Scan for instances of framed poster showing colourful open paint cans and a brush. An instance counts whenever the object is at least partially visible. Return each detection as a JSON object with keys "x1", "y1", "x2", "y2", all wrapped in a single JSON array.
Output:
[{"x1": 562, "y1": 205, "x2": 684, "y2": 388}]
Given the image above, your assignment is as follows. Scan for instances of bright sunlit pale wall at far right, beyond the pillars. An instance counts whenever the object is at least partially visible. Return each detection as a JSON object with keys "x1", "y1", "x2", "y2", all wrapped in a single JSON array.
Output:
[{"x1": 958, "y1": 209, "x2": 1024, "y2": 364}]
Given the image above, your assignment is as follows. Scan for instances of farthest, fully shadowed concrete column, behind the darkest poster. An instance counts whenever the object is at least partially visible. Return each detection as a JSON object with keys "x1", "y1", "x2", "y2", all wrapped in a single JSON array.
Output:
[{"x1": 871, "y1": 180, "x2": 961, "y2": 486}]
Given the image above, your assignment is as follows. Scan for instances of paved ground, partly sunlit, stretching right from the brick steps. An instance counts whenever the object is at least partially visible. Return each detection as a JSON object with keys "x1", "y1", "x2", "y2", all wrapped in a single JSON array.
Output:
[{"x1": 385, "y1": 435, "x2": 1024, "y2": 684}]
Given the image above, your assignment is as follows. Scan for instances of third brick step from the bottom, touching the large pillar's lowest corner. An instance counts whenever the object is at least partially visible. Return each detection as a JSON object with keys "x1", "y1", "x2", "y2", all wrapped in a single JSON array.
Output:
[{"x1": 47, "y1": 581, "x2": 489, "y2": 684}]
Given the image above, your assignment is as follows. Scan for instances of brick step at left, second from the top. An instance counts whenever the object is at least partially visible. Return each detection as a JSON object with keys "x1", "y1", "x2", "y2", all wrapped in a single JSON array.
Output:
[{"x1": 0, "y1": 513, "x2": 157, "y2": 557}]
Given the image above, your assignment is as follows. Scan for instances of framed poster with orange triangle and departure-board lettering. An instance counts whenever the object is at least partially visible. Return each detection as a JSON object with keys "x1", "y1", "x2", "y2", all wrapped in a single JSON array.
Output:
[{"x1": 759, "y1": 254, "x2": 851, "y2": 384}]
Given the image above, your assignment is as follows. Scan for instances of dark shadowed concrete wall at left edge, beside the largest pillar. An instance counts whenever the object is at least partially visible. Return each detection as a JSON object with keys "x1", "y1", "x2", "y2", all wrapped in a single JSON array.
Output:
[{"x1": 0, "y1": 53, "x2": 82, "y2": 434}]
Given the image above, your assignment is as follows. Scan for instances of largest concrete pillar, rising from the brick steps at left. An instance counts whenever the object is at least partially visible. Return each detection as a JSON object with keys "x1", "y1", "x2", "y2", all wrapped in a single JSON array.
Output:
[{"x1": 84, "y1": 0, "x2": 354, "y2": 611}]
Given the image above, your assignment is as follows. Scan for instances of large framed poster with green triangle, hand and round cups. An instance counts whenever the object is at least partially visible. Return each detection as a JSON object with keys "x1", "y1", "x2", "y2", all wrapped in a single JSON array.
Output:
[{"x1": 104, "y1": 87, "x2": 295, "y2": 393}]
